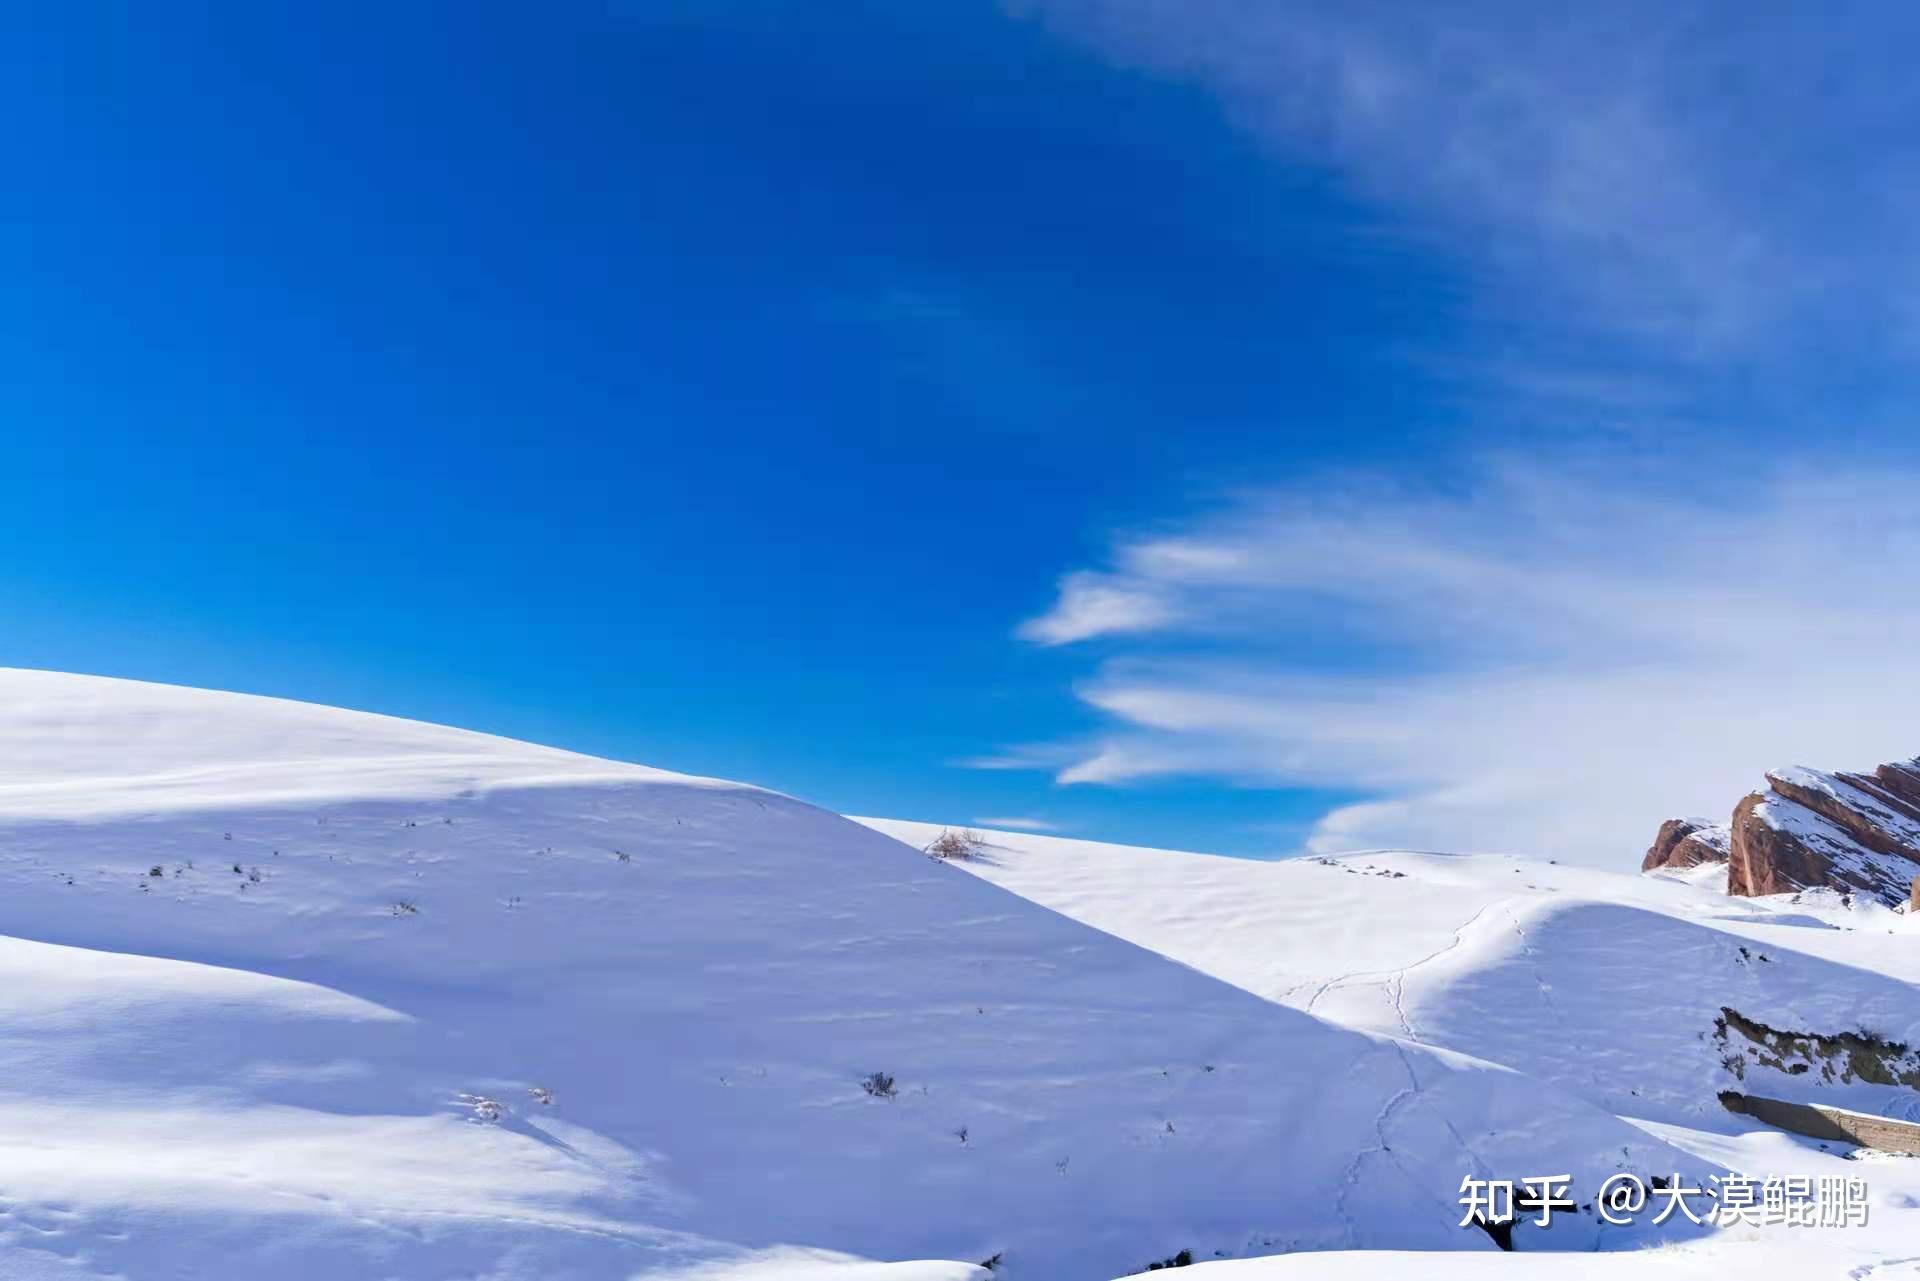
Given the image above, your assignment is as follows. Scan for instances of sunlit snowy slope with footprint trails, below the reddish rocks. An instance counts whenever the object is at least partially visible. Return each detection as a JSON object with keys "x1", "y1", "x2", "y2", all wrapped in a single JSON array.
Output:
[{"x1": 858, "y1": 818, "x2": 1920, "y2": 1281}]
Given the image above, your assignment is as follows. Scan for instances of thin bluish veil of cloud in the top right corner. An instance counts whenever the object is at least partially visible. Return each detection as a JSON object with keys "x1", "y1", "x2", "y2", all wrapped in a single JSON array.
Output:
[{"x1": 1014, "y1": 0, "x2": 1920, "y2": 355}]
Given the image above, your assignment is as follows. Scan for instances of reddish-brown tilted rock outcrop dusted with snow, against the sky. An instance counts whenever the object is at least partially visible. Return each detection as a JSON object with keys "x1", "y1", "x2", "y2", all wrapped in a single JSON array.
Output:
[{"x1": 1642, "y1": 761, "x2": 1920, "y2": 906}]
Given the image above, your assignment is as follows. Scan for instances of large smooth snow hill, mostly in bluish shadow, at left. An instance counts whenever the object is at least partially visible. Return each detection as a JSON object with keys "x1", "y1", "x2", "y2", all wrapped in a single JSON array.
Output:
[{"x1": 0, "y1": 670, "x2": 1716, "y2": 1281}]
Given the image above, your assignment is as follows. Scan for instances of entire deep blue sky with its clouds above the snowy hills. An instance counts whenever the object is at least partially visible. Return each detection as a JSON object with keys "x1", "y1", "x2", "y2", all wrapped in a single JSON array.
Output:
[{"x1": 11, "y1": 0, "x2": 1920, "y2": 853}]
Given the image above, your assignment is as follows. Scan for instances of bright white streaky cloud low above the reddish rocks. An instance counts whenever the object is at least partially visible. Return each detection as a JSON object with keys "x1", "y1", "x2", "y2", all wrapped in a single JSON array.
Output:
[{"x1": 1012, "y1": 459, "x2": 1920, "y2": 866}]
